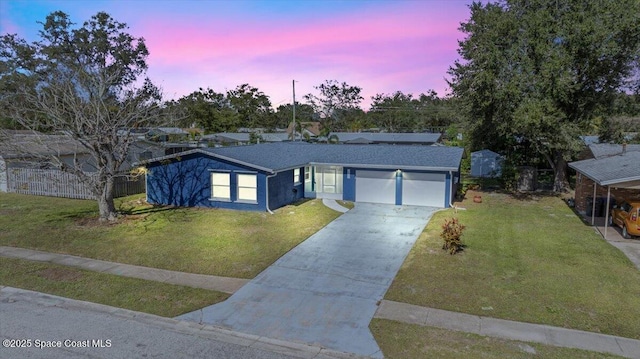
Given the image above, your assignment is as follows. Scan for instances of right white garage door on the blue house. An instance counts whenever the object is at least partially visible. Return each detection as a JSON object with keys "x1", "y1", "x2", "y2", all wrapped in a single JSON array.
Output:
[{"x1": 402, "y1": 172, "x2": 446, "y2": 207}]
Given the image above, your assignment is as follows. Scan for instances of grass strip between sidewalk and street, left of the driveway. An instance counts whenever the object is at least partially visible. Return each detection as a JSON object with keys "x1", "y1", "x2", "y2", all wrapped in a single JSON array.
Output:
[{"x1": 0, "y1": 257, "x2": 229, "y2": 317}]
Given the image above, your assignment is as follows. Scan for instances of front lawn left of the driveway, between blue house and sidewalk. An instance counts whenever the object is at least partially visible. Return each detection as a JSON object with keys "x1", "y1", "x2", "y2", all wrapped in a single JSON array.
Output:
[{"x1": 0, "y1": 193, "x2": 340, "y2": 279}]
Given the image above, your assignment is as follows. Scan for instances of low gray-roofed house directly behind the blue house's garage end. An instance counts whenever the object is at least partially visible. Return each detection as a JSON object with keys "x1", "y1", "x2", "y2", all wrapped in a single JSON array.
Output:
[{"x1": 328, "y1": 132, "x2": 442, "y2": 145}]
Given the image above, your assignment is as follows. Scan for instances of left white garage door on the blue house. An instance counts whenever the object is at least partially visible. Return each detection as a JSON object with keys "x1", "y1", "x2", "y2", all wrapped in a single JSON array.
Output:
[{"x1": 356, "y1": 170, "x2": 396, "y2": 204}]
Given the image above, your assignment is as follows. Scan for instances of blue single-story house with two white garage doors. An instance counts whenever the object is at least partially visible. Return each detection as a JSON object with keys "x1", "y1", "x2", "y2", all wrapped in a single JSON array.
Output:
[{"x1": 142, "y1": 142, "x2": 463, "y2": 211}]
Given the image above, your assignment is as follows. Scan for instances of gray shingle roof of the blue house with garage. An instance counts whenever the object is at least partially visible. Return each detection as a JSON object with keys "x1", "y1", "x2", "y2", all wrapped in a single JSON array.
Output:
[{"x1": 140, "y1": 142, "x2": 463, "y2": 172}]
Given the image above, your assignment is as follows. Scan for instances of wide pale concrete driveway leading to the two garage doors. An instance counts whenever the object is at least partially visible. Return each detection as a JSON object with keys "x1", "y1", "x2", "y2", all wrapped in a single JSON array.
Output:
[{"x1": 178, "y1": 203, "x2": 436, "y2": 357}]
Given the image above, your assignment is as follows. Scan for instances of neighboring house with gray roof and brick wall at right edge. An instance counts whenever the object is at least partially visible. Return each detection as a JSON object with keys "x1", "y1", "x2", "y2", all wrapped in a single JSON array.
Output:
[{"x1": 569, "y1": 144, "x2": 640, "y2": 217}]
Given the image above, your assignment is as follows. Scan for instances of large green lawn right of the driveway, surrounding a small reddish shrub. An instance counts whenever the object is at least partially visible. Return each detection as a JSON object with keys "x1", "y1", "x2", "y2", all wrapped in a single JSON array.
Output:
[{"x1": 385, "y1": 191, "x2": 640, "y2": 339}]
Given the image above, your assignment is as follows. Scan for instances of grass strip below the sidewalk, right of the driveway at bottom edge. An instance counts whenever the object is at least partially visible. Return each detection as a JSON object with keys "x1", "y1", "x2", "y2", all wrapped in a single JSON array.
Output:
[{"x1": 369, "y1": 319, "x2": 619, "y2": 359}]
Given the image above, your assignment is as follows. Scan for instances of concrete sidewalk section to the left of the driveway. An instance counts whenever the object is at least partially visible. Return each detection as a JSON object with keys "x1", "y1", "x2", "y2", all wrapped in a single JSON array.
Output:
[{"x1": 0, "y1": 247, "x2": 249, "y2": 294}]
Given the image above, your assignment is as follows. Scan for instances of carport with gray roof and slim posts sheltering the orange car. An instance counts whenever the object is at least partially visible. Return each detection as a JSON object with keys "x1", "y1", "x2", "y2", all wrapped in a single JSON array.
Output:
[{"x1": 569, "y1": 151, "x2": 640, "y2": 237}]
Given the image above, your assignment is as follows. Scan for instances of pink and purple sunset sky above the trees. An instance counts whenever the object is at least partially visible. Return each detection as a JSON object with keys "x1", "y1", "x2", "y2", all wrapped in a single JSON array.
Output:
[{"x1": 0, "y1": 0, "x2": 471, "y2": 110}]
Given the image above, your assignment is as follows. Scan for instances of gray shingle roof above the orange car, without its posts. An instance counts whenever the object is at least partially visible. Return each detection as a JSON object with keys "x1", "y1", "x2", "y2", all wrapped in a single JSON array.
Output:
[{"x1": 569, "y1": 150, "x2": 640, "y2": 186}]
